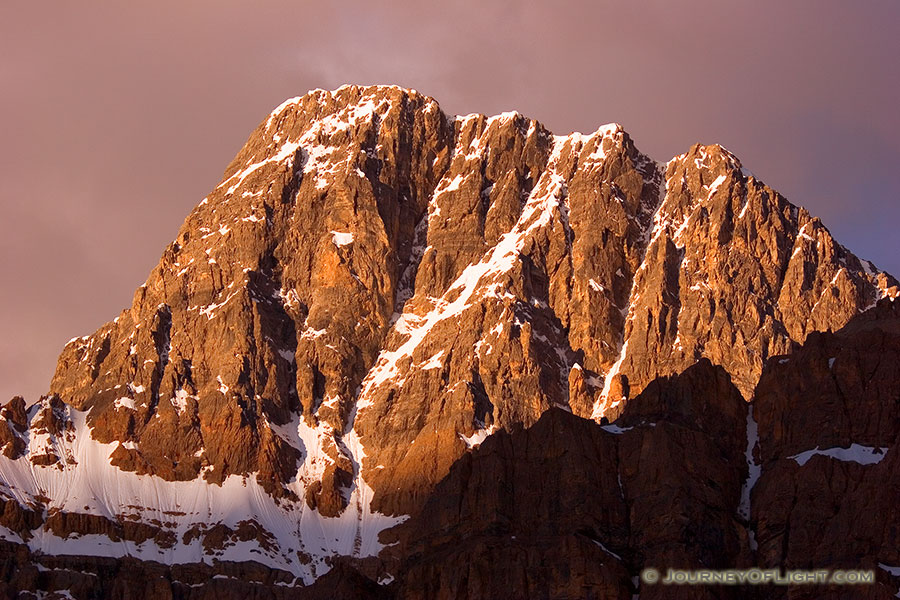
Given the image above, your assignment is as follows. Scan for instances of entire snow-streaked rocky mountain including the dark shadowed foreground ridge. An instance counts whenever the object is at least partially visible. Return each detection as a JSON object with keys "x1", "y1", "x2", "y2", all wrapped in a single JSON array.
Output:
[{"x1": 0, "y1": 86, "x2": 900, "y2": 600}]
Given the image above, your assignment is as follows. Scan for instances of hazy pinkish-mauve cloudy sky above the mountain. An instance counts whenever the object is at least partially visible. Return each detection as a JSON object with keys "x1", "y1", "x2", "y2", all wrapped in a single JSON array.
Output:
[{"x1": 0, "y1": 0, "x2": 900, "y2": 401}]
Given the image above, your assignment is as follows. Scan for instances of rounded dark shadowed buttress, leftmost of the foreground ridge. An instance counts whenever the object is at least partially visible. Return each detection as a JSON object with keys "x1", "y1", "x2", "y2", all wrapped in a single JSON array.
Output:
[{"x1": 398, "y1": 408, "x2": 631, "y2": 599}]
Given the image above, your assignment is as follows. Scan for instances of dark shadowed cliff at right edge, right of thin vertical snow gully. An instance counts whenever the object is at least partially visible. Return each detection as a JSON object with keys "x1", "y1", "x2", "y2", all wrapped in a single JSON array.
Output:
[{"x1": 752, "y1": 301, "x2": 900, "y2": 598}]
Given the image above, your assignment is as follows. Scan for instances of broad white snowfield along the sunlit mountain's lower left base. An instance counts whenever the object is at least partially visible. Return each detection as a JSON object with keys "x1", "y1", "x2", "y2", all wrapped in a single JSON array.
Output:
[{"x1": 0, "y1": 400, "x2": 405, "y2": 584}]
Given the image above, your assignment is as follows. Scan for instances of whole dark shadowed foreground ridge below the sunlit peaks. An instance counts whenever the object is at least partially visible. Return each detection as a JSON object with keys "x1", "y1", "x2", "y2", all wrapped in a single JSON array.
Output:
[{"x1": 383, "y1": 301, "x2": 900, "y2": 599}]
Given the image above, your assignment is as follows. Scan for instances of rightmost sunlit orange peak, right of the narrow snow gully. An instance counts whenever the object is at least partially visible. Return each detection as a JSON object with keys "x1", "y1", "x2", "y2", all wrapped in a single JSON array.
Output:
[{"x1": 595, "y1": 145, "x2": 897, "y2": 415}]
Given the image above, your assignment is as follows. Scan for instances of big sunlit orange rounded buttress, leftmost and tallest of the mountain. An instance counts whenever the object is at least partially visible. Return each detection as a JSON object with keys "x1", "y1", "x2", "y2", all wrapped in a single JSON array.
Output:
[{"x1": 51, "y1": 88, "x2": 452, "y2": 494}]
